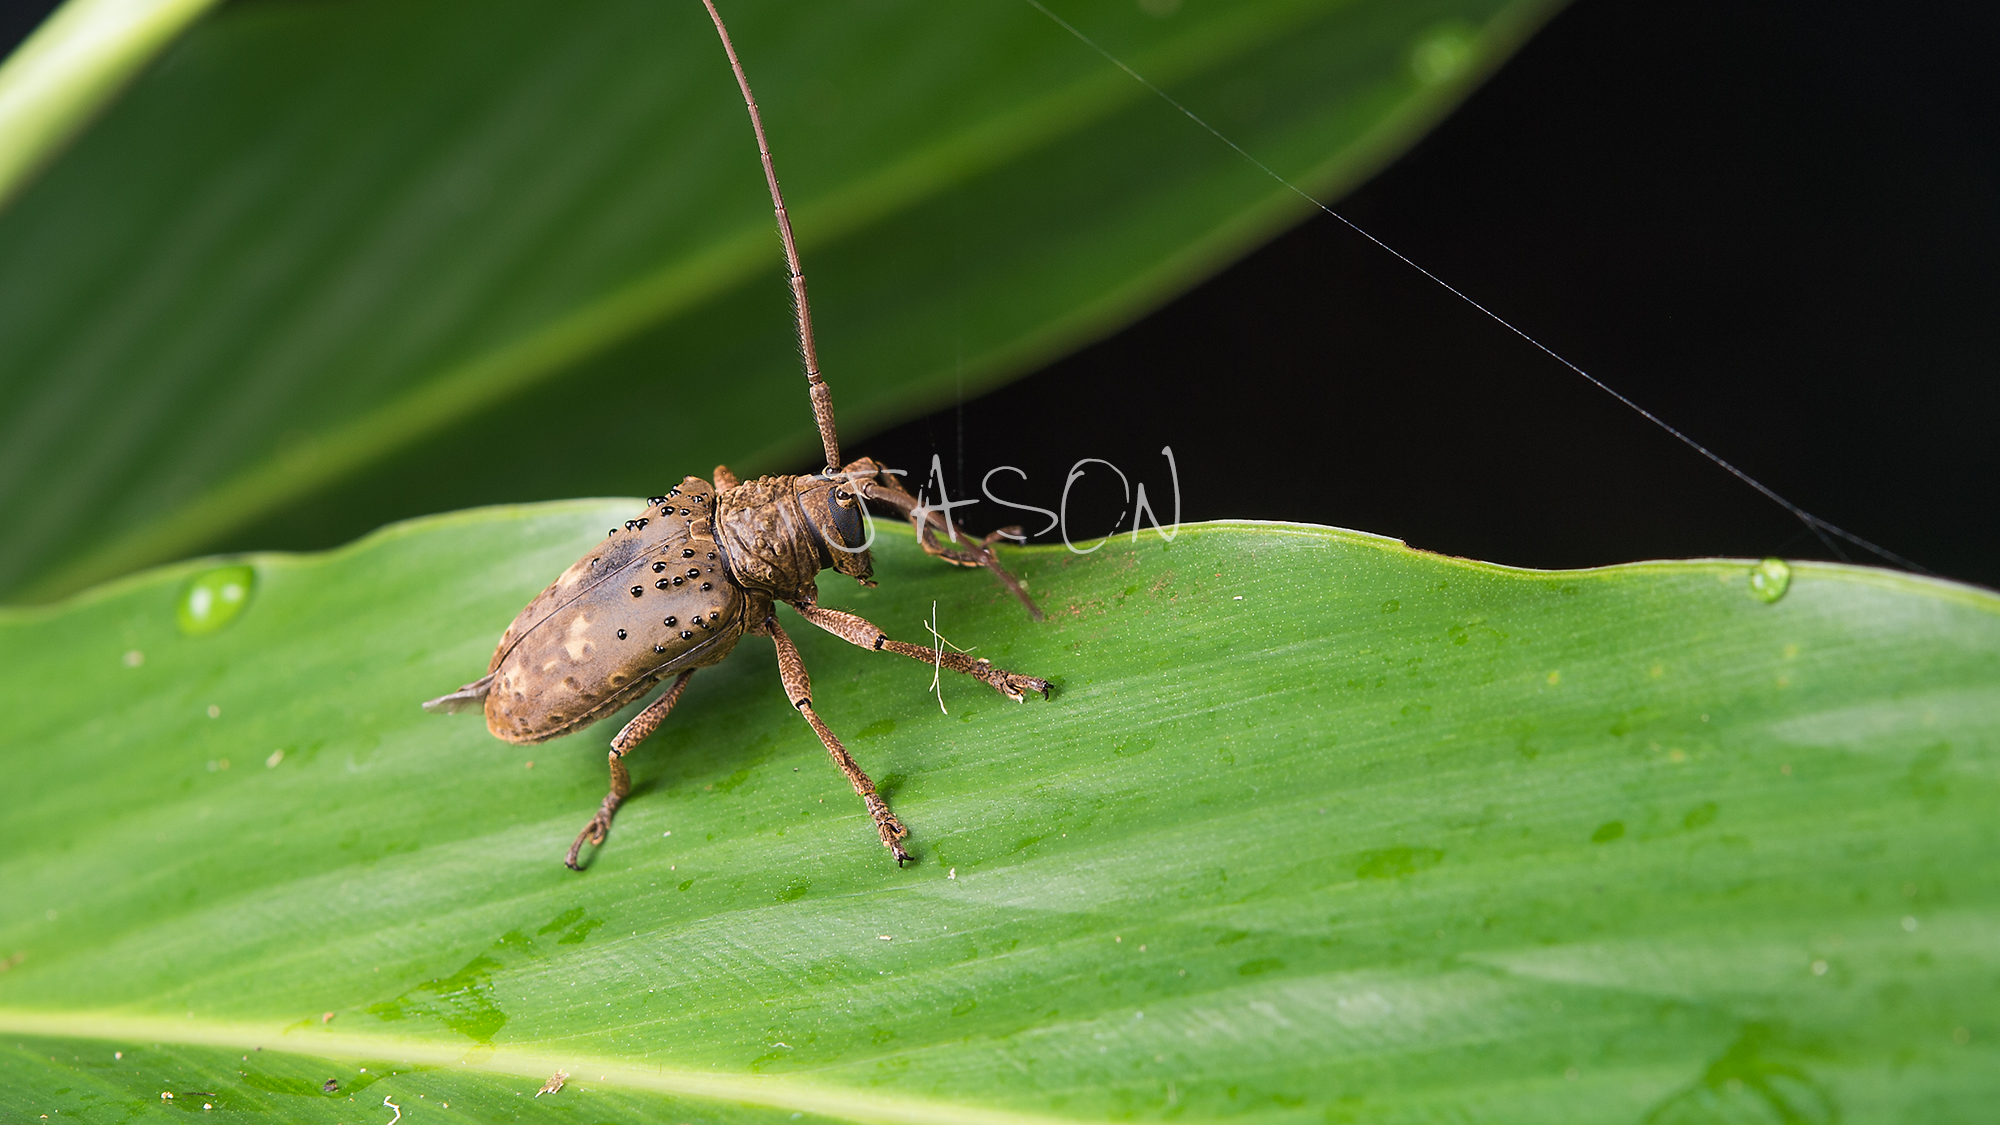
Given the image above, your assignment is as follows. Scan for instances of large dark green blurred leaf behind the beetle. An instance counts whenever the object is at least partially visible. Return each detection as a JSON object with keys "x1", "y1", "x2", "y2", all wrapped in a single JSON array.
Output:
[{"x1": 0, "y1": 0, "x2": 1552, "y2": 601}]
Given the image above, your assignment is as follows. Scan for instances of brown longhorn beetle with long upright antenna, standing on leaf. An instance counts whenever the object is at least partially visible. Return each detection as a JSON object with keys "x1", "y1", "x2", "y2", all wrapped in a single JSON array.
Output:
[{"x1": 424, "y1": 0, "x2": 1048, "y2": 869}]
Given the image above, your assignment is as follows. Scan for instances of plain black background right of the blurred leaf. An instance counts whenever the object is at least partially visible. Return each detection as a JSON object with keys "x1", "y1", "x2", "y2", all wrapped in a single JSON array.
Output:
[{"x1": 864, "y1": 0, "x2": 2000, "y2": 585}]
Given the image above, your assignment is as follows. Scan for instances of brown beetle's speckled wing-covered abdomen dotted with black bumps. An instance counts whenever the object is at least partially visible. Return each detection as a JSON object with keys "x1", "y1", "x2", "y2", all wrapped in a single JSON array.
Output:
[{"x1": 486, "y1": 476, "x2": 744, "y2": 743}]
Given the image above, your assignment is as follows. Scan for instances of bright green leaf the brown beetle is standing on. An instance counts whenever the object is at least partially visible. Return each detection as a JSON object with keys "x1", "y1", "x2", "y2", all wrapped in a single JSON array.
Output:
[{"x1": 0, "y1": 500, "x2": 2000, "y2": 1123}]
